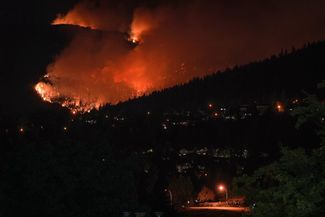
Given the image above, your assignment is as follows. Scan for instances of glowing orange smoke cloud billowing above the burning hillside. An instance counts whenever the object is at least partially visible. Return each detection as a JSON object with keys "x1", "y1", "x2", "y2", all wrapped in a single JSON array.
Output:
[{"x1": 35, "y1": 0, "x2": 325, "y2": 111}]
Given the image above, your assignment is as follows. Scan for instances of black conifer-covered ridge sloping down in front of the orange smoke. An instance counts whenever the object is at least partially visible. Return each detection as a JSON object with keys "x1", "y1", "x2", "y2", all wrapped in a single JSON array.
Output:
[{"x1": 113, "y1": 41, "x2": 325, "y2": 112}]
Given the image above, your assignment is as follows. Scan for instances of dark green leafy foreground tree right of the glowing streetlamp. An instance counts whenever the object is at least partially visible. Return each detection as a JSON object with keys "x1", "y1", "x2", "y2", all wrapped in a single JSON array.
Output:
[{"x1": 234, "y1": 82, "x2": 325, "y2": 217}]
